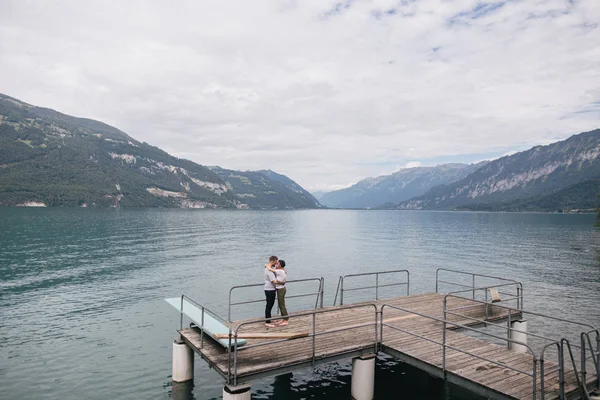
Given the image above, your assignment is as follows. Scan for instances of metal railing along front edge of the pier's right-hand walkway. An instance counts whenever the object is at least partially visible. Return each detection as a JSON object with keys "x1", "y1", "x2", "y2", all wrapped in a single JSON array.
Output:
[{"x1": 379, "y1": 304, "x2": 538, "y2": 400}]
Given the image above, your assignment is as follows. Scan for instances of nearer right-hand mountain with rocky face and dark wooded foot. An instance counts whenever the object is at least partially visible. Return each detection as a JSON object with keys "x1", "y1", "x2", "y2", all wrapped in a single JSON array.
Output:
[{"x1": 394, "y1": 129, "x2": 600, "y2": 211}]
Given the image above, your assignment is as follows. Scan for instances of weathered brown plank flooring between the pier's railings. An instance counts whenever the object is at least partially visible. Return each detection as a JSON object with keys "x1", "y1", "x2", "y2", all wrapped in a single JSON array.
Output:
[{"x1": 179, "y1": 293, "x2": 595, "y2": 399}]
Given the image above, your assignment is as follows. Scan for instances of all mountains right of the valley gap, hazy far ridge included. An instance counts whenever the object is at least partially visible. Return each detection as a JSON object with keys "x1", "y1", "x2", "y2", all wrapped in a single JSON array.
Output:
[{"x1": 319, "y1": 129, "x2": 600, "y2": 211}]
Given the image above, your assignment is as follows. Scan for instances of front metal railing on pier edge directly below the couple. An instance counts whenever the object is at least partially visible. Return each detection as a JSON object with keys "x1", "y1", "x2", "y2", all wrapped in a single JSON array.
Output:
[{"x1": 227, "y1": 304, "x2": 379, "y2": 385}]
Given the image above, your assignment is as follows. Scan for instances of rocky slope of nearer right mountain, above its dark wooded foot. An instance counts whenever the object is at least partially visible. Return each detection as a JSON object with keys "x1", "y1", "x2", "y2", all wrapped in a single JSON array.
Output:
[{"x1": 397, "y1": 130, "x2": 600, "y2": 209}]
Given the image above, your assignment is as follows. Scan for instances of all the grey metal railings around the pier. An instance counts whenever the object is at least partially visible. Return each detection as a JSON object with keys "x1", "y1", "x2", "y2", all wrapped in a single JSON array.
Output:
[{"x1": 172, "y1": 268, "x2": 600, "y2": 400}]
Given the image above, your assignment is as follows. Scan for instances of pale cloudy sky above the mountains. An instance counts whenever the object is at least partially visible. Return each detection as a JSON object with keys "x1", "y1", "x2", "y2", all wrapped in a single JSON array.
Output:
[{"x1": 0, "y1": 0, "x2": 600, "y2": 190}]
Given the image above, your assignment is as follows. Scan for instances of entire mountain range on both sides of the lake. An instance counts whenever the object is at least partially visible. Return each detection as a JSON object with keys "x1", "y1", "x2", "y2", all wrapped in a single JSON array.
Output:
[{"x1": 0, "y1": 94, "x2": 600, "y2": 211}]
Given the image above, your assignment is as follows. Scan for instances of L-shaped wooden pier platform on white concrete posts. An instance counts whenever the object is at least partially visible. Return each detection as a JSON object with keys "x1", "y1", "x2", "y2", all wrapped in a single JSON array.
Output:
[{"x1": 170, "y1": 268, "x2": 600, "y2": 399}]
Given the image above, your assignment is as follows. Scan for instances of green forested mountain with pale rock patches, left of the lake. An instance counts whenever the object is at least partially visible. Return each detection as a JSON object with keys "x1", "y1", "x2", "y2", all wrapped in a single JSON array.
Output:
[{"x1": 0, "y1": 94, "x2": 320, "y2": 209}]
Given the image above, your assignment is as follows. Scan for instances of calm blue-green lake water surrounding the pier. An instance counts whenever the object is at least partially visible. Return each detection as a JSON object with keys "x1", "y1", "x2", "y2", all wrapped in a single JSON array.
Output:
[{"x1": 0, "y1": 208, "x2": 600, "y2": 399}]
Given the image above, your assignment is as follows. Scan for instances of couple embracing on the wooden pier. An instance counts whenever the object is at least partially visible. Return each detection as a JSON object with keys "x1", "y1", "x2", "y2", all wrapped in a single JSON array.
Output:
[{"x1": 265, "y1": 256, "x2": 289, "y2": 328}]
